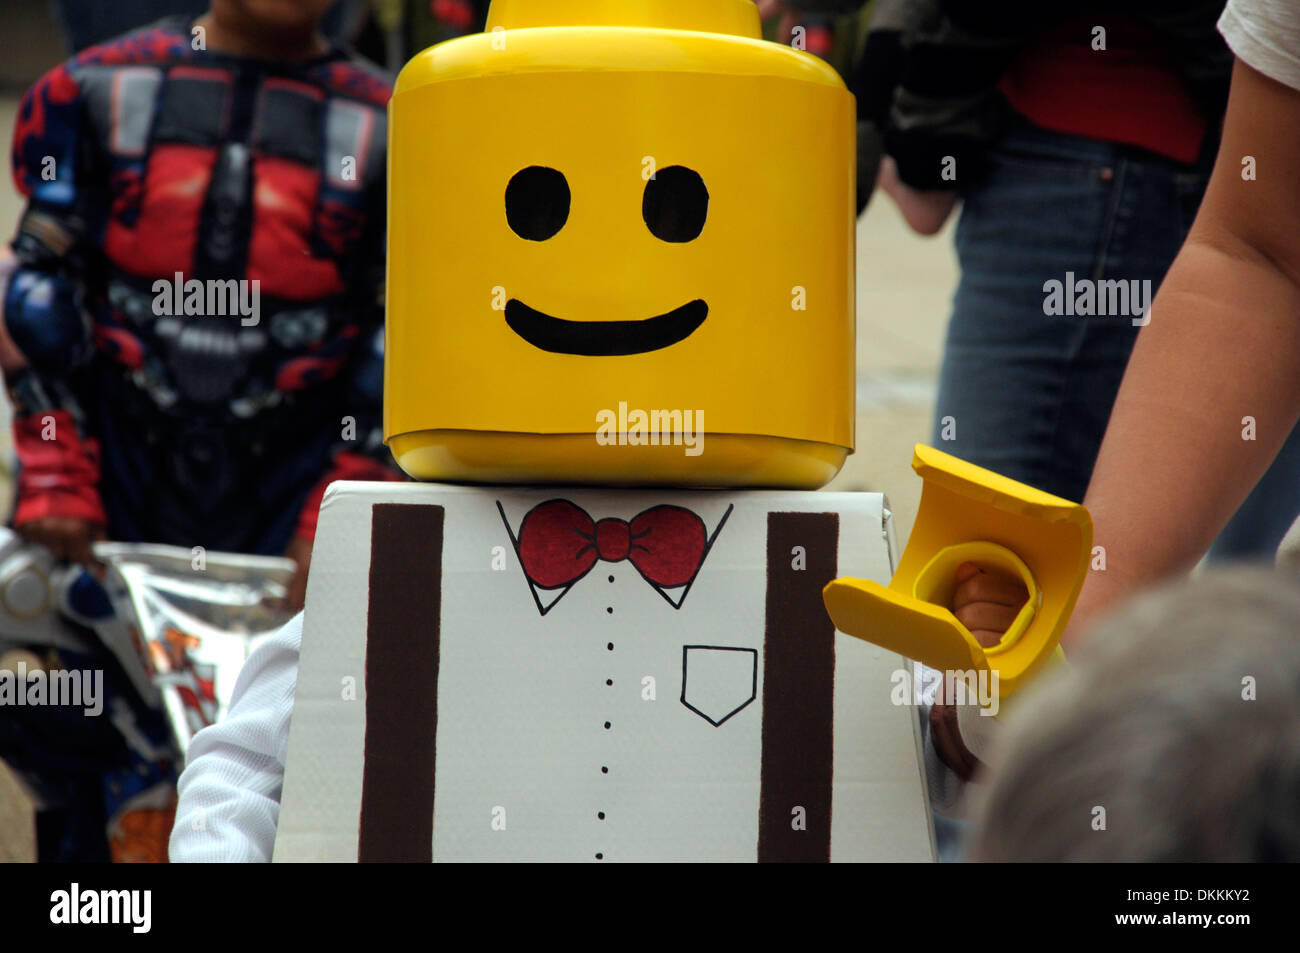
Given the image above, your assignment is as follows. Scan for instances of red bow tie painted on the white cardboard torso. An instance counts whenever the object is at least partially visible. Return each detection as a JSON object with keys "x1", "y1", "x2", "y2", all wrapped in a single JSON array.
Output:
[{"x1": 519, "y1": 499, "x2": 707, "y2": 589}]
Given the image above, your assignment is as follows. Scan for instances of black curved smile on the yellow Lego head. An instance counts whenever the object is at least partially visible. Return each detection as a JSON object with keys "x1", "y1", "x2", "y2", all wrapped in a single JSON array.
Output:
[{"x1": 506, "y1": 298, "x2": 709, "y2": 358}]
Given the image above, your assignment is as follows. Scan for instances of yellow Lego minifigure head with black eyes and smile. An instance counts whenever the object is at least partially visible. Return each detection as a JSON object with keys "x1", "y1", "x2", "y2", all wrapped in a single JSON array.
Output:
[{"x1": 385, "y1": 0, "x2": 854, "y2": 488}]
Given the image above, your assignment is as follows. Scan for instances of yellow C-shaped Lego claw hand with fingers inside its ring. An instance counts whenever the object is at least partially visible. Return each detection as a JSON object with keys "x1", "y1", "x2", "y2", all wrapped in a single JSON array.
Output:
[{"x1": 823, "y1": 445, "x2": 1092, "y2": 697}]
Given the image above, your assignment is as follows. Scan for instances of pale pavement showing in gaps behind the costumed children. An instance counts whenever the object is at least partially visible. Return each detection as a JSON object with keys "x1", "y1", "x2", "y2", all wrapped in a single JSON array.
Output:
[{"x1": 0, "y1": 61, "x2": 957, "y2": 862}]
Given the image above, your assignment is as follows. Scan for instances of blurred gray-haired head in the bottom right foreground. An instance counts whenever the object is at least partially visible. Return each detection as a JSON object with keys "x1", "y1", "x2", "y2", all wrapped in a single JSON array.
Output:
[{"x1": 970, "y1": 568, "x2": 1300, "y2": 861}]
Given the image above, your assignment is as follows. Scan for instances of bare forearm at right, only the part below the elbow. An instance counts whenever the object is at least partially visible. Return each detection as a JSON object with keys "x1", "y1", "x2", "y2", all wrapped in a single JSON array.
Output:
[{"x1": 1070, "y1": 234, "x2": 1300, "y2": 647}]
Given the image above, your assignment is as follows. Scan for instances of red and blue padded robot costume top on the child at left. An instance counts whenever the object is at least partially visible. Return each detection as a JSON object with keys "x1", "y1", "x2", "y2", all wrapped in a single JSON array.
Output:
[{"x1": 4, "y1": 18, "x2": 393, "y2": 554}]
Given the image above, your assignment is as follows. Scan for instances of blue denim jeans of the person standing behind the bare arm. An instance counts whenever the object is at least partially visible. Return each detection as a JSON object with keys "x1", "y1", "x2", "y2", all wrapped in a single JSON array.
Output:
[{"x1": 933, "y1": 122, "x2": 1300, "y2": 559}]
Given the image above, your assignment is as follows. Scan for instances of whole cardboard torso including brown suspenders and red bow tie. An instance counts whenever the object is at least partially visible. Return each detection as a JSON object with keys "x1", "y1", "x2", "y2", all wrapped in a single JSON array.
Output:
[{"x1": 276, "y1": 484, "x2": 932, "y2": 861}]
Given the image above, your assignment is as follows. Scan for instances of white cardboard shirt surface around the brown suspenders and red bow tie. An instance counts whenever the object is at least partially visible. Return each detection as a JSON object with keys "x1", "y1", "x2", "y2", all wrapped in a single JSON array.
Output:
[{"x1": 274, "y1": 482, "x2": 933, "y2": 861}]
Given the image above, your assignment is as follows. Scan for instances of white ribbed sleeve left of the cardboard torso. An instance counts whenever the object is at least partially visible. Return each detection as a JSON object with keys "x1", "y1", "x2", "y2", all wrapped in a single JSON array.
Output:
[{"x1": 170, "y1": 612, "x2": 303, "y2": 863}]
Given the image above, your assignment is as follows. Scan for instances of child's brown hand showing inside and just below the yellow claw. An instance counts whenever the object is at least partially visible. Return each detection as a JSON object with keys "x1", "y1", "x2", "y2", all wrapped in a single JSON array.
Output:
[{"x1": 930, "y1": 563, "x2": 1030, "y2": 781}]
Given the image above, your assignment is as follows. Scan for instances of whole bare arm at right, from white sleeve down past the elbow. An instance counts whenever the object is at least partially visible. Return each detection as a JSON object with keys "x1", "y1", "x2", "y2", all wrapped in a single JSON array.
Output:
[{"x1": 1063, "y1": 61, "x2": 1300, "y2": 650}]
